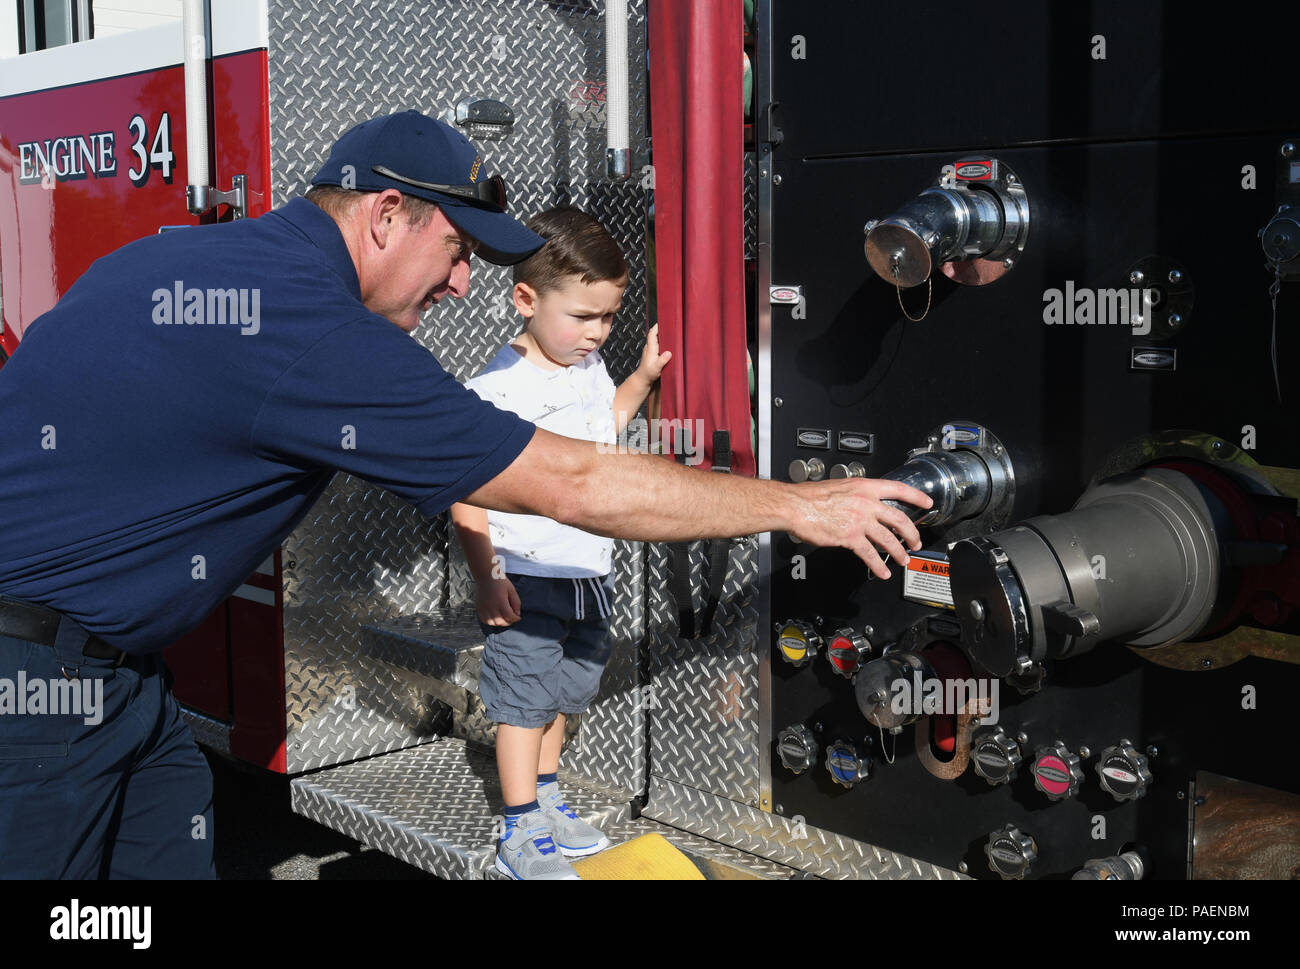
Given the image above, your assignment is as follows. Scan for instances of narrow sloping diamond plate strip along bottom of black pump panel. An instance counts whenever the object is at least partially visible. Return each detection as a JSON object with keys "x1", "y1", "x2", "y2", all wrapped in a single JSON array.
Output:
[{"x1": 641, "y1": 775, "x2": 966, "y2": 881}]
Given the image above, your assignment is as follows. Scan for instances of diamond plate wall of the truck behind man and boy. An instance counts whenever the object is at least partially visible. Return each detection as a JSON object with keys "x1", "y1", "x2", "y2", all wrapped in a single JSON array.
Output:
[{"x1": 268, "y1": 0, "x2": 646, "y2": 769}]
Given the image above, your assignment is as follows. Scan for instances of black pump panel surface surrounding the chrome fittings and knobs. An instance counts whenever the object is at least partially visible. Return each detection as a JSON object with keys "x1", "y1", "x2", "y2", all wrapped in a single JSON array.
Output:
[{"x1": 763, "y1": 0, "x2": 1300, "y2": 878}]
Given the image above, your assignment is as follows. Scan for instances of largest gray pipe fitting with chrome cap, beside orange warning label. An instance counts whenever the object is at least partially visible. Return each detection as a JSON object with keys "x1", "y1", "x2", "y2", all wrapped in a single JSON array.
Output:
[{"x1": 949, "y1": 467, "x2": 1229, "y2": 688}]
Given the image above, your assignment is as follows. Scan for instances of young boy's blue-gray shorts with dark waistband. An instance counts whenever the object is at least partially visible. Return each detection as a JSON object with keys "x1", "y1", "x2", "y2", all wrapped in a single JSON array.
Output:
[{"x1": 478, "y1": 574, "x2": 614, "y2": 727}]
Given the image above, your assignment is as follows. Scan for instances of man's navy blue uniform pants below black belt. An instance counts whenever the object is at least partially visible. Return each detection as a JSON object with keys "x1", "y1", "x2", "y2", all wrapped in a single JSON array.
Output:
[{"x1": 0, "y1": 636, "x2": 216, "y2": 878}]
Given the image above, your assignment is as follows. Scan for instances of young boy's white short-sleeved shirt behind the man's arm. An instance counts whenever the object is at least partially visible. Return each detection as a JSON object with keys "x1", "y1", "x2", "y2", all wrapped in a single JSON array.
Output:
[{"x1": 465, "y1": 343, "x2": 618, "y2": 579}]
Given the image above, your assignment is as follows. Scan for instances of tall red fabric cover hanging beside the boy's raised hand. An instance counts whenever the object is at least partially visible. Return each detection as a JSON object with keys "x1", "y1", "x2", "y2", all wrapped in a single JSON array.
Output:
[{"x1": 649, "y1": 0, "x2": 755, "y2": 476}]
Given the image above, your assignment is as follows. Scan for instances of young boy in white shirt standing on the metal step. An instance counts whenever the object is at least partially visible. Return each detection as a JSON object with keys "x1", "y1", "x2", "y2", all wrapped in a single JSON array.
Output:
[{"x1": 451, "y1": 207, "x2": 672, "y2": 879}]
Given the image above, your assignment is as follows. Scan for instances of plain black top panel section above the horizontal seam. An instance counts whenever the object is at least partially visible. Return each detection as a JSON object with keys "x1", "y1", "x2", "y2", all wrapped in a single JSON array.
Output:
[{"x1": 771, "y1": 0, "x2": 1295, "y2": 156}]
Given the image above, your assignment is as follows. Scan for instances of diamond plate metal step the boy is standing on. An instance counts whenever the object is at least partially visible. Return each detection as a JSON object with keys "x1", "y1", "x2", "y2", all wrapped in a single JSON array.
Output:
[{"x1": 290, "y1": 740, "x2": 631, "y2": 878}]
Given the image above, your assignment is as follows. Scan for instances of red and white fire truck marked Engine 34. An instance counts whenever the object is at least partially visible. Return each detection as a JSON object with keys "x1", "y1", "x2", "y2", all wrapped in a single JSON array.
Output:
[{"x1": 0, "y1": 0, "x2": 1300, "y2": 881}]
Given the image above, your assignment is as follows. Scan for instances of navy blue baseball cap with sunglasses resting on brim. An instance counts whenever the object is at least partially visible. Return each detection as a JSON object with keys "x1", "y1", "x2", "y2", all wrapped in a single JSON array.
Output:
[{"x1": 312, "y1": 111, "x2": 546, "y2": 265}]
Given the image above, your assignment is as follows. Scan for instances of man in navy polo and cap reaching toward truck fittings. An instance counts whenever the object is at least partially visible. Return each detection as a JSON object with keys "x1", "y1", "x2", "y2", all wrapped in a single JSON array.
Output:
[{"x1": 0, "y1": 112, "x2": 930, "y2": 878}]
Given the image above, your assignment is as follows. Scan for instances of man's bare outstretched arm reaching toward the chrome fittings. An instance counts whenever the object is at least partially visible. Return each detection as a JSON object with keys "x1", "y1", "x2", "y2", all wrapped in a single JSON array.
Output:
[{"x1": 464, "y1": 428, "x2": 931, "y2": 579}]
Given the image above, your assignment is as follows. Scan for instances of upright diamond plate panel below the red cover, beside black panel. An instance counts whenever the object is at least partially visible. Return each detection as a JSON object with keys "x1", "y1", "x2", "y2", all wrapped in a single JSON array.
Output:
[{"x1": 646, "y1": 528, "x2": 759, "y2": 801}]
